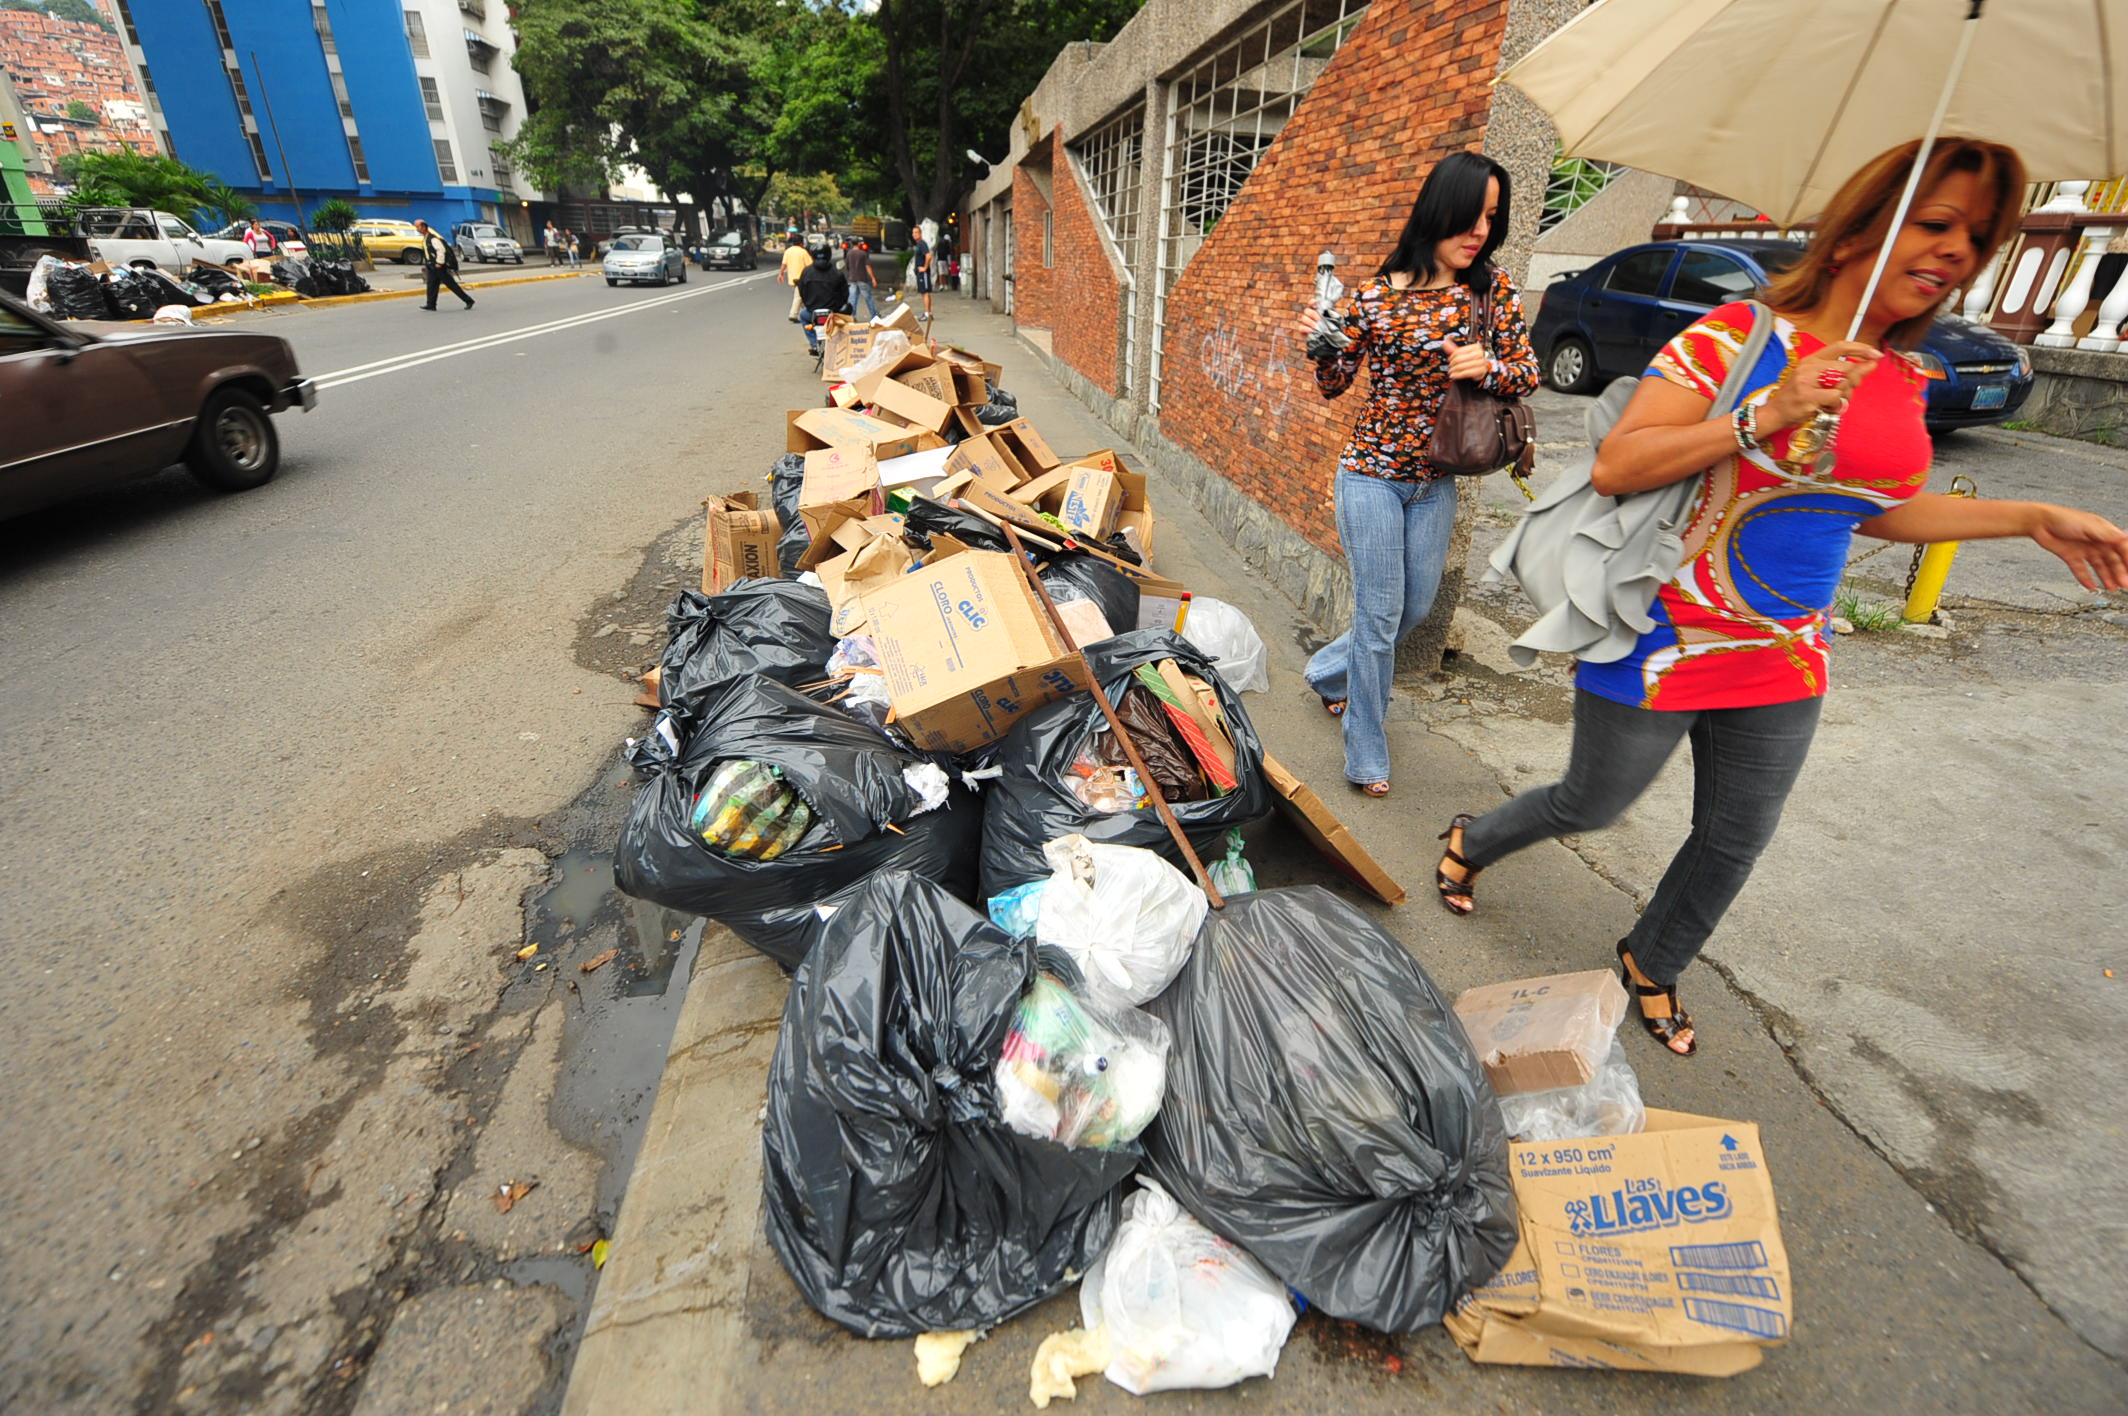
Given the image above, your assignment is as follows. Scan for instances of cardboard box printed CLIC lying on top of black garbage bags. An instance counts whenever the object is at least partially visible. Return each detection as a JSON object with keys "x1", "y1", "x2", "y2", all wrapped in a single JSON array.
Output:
[{"x1": 864, "y1": 551, "x2": 1087, "y2": 752}]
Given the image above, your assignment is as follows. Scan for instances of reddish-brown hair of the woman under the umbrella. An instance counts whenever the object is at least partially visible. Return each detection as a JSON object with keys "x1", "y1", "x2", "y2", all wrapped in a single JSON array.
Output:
[{"x1": 1766, "y1": 138, "x2": 2024, "y2": 347}]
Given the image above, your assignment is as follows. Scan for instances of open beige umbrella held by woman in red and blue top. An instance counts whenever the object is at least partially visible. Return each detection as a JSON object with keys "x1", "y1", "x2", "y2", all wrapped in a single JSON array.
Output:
[{"x1": 1500, "y1": 0, "x2": 2128, "y2": 226}]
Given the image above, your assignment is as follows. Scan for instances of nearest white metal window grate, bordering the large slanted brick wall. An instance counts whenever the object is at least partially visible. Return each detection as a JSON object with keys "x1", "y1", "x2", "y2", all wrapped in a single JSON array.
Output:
[{"x1": 1147, "y1": 0, "x2": 1366, "y2": 411}]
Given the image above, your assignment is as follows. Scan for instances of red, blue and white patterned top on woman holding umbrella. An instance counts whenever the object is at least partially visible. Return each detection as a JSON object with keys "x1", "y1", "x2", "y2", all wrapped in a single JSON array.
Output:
[{"x1": 1575, "y1": 302, "x2": 1930, "y2": 709}]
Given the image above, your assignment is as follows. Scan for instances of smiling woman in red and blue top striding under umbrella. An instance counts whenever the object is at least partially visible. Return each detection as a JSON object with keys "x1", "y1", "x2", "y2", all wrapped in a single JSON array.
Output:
[{"x1": 1436, "y1": 138, "x2": 2128, "y2": 1056}]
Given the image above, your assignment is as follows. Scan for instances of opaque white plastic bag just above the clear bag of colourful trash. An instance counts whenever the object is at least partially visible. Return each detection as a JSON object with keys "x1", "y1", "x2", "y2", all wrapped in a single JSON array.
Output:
[{"x1": 1034, "y1": 835, "x2": 1204, "y2": 1003}]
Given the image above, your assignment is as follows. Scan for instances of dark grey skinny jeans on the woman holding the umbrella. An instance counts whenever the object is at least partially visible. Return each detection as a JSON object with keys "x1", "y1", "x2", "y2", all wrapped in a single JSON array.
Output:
[{"x1": 1462, "y1": 690, "x2": 1824, "y2": 984}]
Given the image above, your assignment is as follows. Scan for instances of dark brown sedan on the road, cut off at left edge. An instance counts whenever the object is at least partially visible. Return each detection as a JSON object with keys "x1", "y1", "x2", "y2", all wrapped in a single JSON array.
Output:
[{"x1": 0, "y1": 294, "x2": 317, "y2": 515}]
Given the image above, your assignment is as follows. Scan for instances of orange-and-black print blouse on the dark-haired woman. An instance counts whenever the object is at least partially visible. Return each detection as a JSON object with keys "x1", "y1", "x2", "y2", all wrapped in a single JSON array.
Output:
[{"x1": 1315, "y1": 268, "x2": 1536, "y2": 481}]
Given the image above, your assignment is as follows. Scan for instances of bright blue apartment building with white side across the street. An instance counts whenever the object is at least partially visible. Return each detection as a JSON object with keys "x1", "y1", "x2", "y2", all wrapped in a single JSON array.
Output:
[{"x1": 117, "y1": 0, "x2": 523, "y2": 232}]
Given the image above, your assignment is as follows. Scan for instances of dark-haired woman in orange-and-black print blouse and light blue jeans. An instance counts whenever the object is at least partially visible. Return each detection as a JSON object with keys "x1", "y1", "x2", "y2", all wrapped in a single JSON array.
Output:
[{"x1": 1302, "y1": 153, "x2": 1536, "y2": 796}]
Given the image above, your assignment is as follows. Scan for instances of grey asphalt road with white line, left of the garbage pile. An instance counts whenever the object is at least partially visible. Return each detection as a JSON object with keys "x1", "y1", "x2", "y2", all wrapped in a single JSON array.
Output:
[{"x1": 0, "y1": 273, "x2": 800, "y2": 1414}]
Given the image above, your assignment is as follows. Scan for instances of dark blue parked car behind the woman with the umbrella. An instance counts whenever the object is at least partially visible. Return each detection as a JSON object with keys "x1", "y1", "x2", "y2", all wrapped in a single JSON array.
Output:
[{"x1": 1530, "y1": 241, "x2": 2032, "y2": 432}]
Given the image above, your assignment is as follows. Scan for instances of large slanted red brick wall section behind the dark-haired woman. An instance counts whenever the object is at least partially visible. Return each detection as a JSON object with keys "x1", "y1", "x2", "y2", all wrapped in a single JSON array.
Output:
[{"x1": 1149, "y1": 0, "x2": 1515, "y2": 554}]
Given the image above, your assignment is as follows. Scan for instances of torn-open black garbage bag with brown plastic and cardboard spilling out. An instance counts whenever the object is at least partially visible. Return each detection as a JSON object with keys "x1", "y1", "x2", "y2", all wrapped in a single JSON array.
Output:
[{"x1": 983, "y1": 630, "x2": 1277, "y2": 899}]
